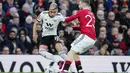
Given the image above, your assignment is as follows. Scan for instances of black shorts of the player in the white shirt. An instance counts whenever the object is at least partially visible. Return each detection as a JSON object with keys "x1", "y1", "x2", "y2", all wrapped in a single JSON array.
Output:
[{"x1": 40, "y1": 36, "x2": 60, "y2": 47}]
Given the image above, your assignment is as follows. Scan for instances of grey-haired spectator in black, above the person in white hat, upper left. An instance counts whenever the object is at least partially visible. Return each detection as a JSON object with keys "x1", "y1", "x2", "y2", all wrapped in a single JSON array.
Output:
[{"x1": 19, "y1": 4, "x2": 31, "y2": 27}]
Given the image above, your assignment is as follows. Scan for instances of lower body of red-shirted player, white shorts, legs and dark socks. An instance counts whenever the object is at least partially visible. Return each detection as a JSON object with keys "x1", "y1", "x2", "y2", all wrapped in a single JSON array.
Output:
[{"x1": 63, "y1": 34, "x2": 95, "y2": 73}]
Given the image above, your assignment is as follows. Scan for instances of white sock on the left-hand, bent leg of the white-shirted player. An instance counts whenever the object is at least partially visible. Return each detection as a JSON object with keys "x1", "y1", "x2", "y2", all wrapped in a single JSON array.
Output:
[{"x1": 39, "y1": 49, "x2": 56, "y2": 62}]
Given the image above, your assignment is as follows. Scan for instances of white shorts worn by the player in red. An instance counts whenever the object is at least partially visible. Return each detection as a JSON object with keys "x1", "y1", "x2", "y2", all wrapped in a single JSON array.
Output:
[{"x1": 71, "y1": 34, "x2": 96, "y2": 54}]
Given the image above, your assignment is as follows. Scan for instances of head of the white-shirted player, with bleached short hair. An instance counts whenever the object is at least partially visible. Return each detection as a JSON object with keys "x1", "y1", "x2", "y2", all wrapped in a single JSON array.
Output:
[{"x1": 49, "y1": 3, "x2": 58, "y2": 17}]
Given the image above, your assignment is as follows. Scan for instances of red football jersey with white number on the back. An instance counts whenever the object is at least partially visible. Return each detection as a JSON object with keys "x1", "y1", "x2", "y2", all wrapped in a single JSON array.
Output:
[{"x1": 65, "y1": 9, "x2": 96, "y2": 40}]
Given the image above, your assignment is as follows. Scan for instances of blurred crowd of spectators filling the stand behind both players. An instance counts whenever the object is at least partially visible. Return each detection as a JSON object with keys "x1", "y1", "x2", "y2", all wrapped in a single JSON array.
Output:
[{"x1": 0, "y1": 0, "x2": 130, "y2": 56}]
